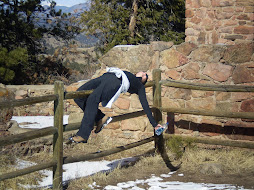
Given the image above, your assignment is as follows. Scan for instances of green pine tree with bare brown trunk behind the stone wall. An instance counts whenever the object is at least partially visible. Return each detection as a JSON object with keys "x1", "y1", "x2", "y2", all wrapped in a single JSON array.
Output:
[{"x1": 81, "y1": 0, "x2": 185, "y2": 51}]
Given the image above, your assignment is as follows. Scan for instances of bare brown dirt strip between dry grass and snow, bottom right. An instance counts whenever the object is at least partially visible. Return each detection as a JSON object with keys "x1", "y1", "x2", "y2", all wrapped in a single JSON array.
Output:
[{"x1": 85, "y1": 158, "x2": 254, "y2": 189}]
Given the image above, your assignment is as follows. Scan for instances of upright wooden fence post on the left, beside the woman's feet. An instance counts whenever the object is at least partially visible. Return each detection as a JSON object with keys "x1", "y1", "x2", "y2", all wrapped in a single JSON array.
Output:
[{"x1": 53, "y1": 81, "x2": 64, "y2": 189}]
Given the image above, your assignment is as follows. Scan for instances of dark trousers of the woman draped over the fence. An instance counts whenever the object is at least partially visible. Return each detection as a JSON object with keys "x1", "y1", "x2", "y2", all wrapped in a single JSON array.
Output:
[{"x1": 74, "y1": 73, "x2": 121, "y2": 140}]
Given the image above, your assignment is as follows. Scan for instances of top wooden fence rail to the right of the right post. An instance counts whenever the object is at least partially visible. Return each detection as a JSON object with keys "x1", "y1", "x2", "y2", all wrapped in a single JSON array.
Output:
[{"x1": 160, "y1": 79, "x2": 254, "y2": 92}]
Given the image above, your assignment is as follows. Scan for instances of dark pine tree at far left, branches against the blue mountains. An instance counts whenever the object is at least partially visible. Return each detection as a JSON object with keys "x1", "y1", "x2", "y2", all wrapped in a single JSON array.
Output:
[{"x1": 0, "y1": 0, "x2": 79, "y2": 84}]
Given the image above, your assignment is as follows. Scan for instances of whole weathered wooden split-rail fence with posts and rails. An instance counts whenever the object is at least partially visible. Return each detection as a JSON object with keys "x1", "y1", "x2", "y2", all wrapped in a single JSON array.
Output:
[{"x1": 0, "y1": 69, "x2": 254, "y2": 189}]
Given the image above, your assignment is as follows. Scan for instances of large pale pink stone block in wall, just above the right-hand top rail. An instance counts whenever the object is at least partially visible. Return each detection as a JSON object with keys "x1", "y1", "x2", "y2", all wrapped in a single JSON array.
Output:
[{"x1": 203, "y1": 63, "x2": 233, "y2": 82}]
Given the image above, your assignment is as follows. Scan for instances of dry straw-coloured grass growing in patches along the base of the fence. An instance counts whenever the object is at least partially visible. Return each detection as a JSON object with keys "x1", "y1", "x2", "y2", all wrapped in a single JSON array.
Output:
[{"x1": 0, "y1": 135, "x2": 254, "y2": 190}]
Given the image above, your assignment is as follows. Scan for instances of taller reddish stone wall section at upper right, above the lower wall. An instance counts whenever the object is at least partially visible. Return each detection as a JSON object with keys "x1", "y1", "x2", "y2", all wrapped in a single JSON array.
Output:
[{"x1": 185, "y1": 0, "x2": 254, "y2": 45}]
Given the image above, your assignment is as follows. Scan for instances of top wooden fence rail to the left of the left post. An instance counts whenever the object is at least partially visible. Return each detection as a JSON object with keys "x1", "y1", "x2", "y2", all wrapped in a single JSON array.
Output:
[{"x1": 0, "y1": 94, "x2": 58, "y2": 109}]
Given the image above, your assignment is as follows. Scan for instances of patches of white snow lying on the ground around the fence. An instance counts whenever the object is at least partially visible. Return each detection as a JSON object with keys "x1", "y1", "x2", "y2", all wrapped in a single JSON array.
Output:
[{"x1": 12, "y1": 116, "x2": 250, "y2": 190}]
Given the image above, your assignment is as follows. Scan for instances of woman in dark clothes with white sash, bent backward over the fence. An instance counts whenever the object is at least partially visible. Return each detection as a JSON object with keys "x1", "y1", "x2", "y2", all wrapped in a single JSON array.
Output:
[{"x1": 68, "y1": 67, "x2": 163, "y2": 143}]
